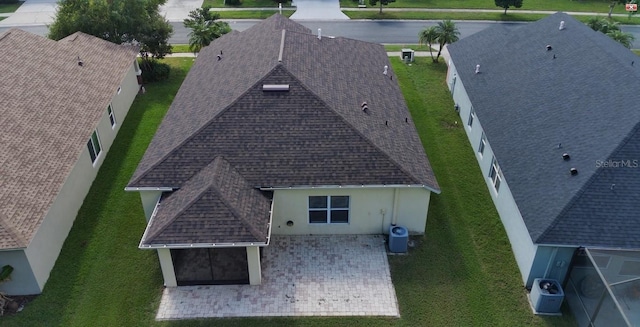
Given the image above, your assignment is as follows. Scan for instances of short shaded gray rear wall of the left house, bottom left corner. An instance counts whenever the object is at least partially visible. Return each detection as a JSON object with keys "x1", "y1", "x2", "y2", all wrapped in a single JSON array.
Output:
[{"x1": 0, "y1": 249, "x2": 40, "y2": 295}]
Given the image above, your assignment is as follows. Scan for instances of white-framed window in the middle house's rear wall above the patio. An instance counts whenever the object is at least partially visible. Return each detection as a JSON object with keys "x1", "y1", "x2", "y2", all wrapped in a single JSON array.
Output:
[{"x1": 309, "y1": 195, "x2": 350, "y2": 224}]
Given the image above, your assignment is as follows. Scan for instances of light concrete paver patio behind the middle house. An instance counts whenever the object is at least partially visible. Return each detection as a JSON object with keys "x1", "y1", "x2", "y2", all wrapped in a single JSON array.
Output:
[{"x1": 156, "y1": 235, "x2": 399, "y2": 320}]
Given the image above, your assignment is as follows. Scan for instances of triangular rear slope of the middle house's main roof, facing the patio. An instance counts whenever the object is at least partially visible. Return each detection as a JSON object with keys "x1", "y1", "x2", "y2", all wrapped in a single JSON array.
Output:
[{"x1": 133, "y1": 65, "x2": 420, "y2": 187}]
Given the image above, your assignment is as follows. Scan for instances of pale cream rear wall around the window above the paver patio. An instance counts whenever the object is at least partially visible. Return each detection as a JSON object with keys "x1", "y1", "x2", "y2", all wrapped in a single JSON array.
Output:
[{"x1": 271, "y1": 187, "x2": 431, "y2": 235}]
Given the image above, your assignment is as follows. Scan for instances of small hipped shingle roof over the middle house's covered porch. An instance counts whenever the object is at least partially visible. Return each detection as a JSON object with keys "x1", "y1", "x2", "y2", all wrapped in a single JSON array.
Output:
[{"x1": 142, "y1": 157, "x2": 271, "y2": 245}]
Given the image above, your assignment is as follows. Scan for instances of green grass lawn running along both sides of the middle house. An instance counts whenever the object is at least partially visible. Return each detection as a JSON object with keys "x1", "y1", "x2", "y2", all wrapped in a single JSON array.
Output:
[{"x1": 0, "y1": 58, "x2": 575, "y2": 327}]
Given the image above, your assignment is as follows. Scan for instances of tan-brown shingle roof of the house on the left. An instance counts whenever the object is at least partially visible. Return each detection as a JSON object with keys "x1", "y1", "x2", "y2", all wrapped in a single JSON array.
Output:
[{"x1": 0, "y1": 29, "x2": 137, "y2": 249}]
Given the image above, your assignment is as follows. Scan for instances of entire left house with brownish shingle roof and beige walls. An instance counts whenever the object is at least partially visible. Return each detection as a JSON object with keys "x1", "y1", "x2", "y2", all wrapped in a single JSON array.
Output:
[{"x1": 0, "y1": 29, "x2": 140, "y2": 295}]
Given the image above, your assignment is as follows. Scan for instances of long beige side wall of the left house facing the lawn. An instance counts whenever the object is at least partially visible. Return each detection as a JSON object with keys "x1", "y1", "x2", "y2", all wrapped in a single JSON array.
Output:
[{"x1": 21, "y1": 62, "x2": 138, "y2": 295}]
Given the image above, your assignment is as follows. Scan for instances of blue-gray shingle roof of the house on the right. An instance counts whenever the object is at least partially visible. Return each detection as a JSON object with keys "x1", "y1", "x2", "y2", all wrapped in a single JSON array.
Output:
[{"x1": 448, "y1": 13, "x2": 640, "y2": 248}]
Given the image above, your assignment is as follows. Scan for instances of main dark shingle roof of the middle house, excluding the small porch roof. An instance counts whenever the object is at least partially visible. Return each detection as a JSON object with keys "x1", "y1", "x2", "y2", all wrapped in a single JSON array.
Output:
[{"x1": 129, "y1": 15, "x2": 439, "y2": 191}]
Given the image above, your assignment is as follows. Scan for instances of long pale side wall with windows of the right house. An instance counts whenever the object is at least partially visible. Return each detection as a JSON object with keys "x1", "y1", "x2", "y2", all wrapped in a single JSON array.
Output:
[{"x1": 447, "y1": 62, "x2": 546, "y2": 287}]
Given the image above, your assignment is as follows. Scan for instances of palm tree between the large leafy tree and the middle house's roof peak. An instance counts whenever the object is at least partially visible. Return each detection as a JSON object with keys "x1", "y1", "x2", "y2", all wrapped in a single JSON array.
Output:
[{"x1": 183, "y1": 6, "x2": 231, "y2": 54}]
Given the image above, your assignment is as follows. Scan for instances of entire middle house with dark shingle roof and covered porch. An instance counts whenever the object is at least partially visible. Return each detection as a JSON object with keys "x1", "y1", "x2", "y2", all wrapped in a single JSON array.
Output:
[{"x1": 126, "y1": 15, "x2": 440, "y2": 286}]
